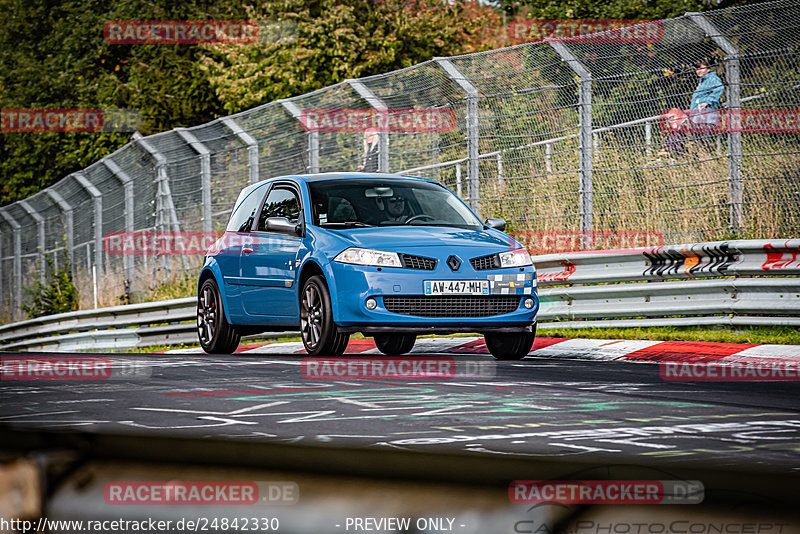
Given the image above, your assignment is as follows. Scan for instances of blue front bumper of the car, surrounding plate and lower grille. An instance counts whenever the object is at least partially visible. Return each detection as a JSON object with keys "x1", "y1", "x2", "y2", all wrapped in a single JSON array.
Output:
[{"x1": 330, "y1": 262, "x2": 539, "y2": 334}]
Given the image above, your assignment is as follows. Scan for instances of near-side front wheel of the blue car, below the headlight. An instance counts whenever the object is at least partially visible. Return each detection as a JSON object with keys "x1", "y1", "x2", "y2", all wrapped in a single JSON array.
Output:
[{"x1": 300, "y1": 275, "x2": 350, "y2": 356}]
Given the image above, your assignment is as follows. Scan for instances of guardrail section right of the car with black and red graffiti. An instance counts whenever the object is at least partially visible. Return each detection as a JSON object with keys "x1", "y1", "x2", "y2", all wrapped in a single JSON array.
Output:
[{"x1": 534, "y1": 239, "x2": 800, "y2": 328}]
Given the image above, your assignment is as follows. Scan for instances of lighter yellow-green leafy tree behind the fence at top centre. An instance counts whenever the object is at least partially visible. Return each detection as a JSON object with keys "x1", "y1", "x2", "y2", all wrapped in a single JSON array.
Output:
[{"x1": 203, "y1": 0, "x2": 500, "y2": 112}]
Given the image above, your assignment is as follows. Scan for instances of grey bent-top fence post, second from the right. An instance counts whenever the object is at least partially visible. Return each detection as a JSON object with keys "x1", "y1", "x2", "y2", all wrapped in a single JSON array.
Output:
[{"x1": 547, "y1": 41, "x2": 594, "y2": 241}]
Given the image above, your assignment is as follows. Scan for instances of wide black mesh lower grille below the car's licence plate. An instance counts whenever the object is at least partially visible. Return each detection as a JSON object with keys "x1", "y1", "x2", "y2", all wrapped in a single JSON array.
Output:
[{"x1": 383, "y1": 295, "x2": 520, "y2": 317}]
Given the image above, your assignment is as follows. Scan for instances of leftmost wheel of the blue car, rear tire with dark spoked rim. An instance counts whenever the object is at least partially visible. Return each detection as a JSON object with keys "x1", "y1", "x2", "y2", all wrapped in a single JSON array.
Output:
[{"x1": 197, "y1": 278, "x2": 242, "y2": 354}]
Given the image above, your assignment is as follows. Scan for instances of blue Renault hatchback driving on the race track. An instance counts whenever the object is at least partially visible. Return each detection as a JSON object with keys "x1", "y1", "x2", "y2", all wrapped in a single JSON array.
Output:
[{"x1": 197, "y1": 173, "x2": 539, "y2": 359}]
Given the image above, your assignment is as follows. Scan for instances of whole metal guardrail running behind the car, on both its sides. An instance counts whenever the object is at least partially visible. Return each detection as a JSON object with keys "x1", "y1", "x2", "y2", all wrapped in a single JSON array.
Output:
[{"x1": 0, "y1": 239, "x2": 800, "y2": 351}]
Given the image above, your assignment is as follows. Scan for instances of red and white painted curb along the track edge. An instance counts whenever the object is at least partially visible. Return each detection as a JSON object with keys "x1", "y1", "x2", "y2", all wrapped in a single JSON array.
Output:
[{"x1": 167, "y1": 337, "x2": 800, "y2": 363}]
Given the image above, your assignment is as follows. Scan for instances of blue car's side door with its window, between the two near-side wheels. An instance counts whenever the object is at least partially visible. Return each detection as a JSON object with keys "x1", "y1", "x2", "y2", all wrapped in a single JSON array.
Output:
[{"x1": 240, "y1": 182, "x2": 303, "y2": 317}]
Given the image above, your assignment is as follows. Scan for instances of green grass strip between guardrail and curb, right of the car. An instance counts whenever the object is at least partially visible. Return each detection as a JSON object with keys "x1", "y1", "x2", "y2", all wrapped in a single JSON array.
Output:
[{"x1": 536, "y1": 326, "x2": 800, "y2": 345}]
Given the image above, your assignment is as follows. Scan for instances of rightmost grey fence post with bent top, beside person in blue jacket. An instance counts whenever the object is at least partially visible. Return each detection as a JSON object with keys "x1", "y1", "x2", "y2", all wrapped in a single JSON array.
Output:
[{"x1": 686, "y1": 12, "x2": 744, "y2": 233}]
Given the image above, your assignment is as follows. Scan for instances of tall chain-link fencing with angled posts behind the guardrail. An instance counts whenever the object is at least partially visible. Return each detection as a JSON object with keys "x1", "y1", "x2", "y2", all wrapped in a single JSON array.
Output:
[{"x1": 0, "y1": 0, "x2": 800, "y2": 320}]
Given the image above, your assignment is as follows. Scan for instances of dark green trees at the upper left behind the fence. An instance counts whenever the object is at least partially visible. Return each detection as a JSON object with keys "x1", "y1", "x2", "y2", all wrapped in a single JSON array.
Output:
[{"x1": 0, "y1": 0, "x2": 244, "y2": 205}]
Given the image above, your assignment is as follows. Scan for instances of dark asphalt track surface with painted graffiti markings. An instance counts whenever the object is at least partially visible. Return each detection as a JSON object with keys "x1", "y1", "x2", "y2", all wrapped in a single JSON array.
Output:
[{"x1": 0, "y1": 344, "x2": 800, "y2": 473}]
